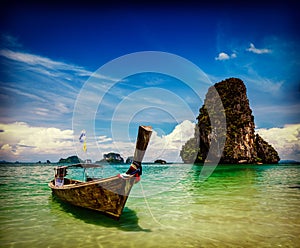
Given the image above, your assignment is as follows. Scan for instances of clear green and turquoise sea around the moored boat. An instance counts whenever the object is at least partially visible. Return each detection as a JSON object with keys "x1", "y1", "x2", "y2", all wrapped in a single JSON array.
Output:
[{"x1": 0, "y1": 164, "x2": 300, "y2": 248}]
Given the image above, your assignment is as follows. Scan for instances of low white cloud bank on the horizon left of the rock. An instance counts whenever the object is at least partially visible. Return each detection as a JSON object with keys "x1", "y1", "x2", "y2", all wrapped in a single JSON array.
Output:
[{"x1": 0, "y1": 120, "x2": 195, "y2": 162}]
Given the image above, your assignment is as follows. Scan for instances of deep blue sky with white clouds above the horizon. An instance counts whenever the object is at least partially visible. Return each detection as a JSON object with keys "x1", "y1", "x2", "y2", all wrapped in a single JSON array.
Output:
[{"x1": 0, "y1": 2, "x2": 300, "y2": 162}]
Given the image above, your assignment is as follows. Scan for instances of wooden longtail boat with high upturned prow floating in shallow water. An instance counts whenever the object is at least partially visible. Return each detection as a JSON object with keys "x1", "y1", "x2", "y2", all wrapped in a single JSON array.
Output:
[{"x1": 48, "y1": 126, "x2": 152, "y2": 220}]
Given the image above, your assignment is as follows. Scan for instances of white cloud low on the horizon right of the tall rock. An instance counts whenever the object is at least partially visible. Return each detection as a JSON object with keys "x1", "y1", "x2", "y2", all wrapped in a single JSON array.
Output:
[{"x1": 256, "y1": 124, "x2": 300, "y2": 161}]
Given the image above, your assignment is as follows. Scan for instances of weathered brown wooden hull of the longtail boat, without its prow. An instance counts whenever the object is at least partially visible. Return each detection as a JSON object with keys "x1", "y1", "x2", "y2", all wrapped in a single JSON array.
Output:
[{"x1": 49, "y1": 176, "x2": 135, "y2": 220}]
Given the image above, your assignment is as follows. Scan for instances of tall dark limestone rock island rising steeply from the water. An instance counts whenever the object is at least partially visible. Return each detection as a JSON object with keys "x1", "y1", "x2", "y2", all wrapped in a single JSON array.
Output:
[{"x1": 180, "y1": 78, "x2": 279, "y2": 164}]
